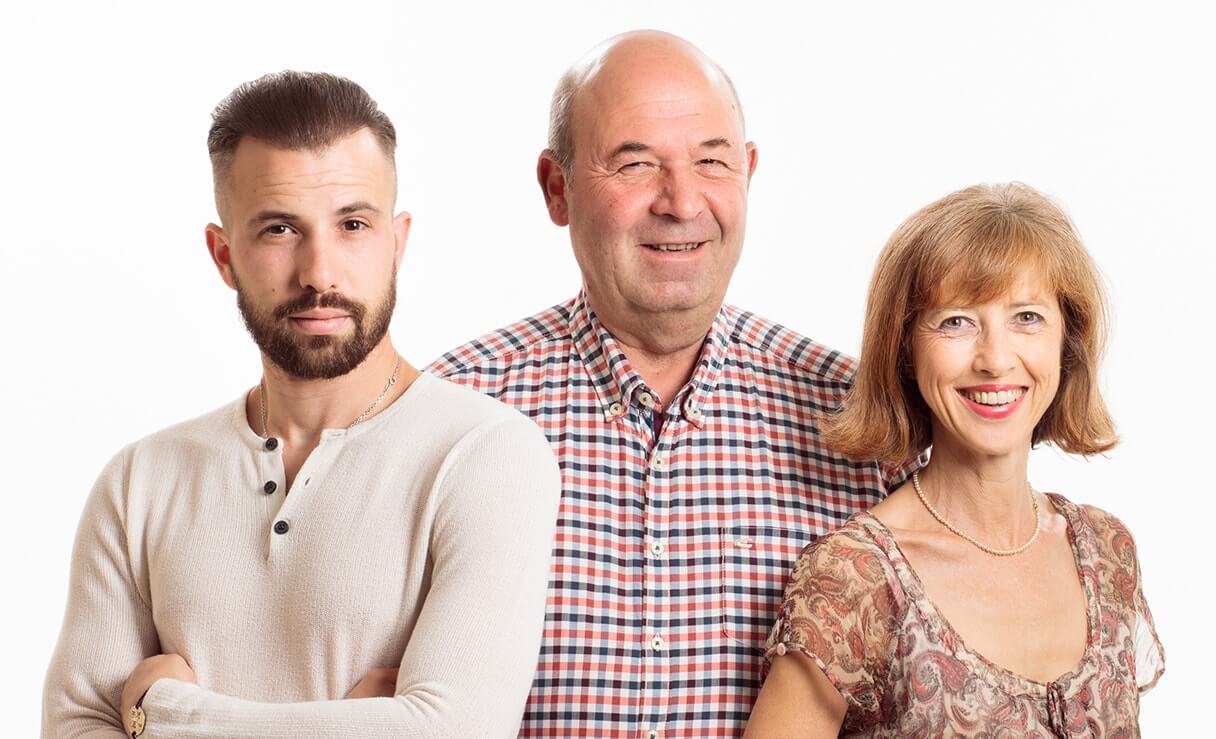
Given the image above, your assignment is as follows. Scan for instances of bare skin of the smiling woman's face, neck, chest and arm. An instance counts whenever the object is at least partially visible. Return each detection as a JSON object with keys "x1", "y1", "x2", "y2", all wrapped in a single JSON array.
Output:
[{"x1": 748, "y1": 269, "x2": 1086, "y2": 737}]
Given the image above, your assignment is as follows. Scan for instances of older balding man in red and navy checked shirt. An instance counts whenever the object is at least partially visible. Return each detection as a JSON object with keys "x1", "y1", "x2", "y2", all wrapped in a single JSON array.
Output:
[{"x1": 429, "y1": 32, "x2": 896, "y2": 739}]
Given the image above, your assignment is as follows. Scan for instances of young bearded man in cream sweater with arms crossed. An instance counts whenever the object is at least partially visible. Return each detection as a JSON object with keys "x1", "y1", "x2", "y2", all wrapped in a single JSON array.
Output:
[{"x1": 43, "y1": 72, "x2": 559, "y2": 739}]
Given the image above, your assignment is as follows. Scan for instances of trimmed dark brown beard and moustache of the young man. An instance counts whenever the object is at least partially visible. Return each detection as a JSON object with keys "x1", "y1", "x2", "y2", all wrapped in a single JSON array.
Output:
[{"x1": 232, "y1": 272, "x2": 396, "y2": 379}]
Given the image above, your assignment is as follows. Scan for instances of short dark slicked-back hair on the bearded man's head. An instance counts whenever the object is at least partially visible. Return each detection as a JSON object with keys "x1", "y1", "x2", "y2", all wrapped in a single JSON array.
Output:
[{"x1": 207, "y1": 69, "x2": 396, "y2": 191}]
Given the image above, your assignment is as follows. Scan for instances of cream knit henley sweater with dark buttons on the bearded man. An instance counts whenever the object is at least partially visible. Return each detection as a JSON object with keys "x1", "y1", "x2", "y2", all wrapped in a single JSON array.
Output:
[{"x1": 43, "y1": 373, "x2": 561, "y2": 739}]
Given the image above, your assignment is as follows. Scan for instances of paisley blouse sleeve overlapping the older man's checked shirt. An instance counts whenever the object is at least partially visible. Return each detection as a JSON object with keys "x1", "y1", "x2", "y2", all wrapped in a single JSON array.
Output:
[{"x1": 765, "y1": 524, "x2": 901, "y2": 732}]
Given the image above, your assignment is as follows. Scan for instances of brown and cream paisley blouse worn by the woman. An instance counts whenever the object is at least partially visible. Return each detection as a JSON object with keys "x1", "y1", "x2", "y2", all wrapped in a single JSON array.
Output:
[{"x1": 766, "y1": 493, "x2": 1165, "y2": 738}]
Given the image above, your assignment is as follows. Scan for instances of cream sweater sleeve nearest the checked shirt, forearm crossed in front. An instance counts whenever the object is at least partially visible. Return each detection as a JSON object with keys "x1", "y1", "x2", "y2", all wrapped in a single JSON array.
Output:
[{"x1": 136, "y1": 417, "x2": 561, "y2": 739}]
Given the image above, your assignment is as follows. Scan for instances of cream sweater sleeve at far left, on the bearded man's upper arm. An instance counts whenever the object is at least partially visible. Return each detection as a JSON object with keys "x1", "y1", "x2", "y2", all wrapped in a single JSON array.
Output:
[{"x1": 43, "y1": 451, "x2": 159, "y2": 739}]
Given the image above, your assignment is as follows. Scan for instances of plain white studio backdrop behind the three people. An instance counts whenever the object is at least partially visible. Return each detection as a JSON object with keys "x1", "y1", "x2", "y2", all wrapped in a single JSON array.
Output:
[{"x1": 0, "y1": 0, "x2": 1216, "y2": 737}]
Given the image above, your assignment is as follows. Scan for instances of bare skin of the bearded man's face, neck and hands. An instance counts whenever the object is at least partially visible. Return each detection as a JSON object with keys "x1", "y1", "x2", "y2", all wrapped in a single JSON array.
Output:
[{"x1": 122, "y1": 129, "x2": 418, "y2": 717}]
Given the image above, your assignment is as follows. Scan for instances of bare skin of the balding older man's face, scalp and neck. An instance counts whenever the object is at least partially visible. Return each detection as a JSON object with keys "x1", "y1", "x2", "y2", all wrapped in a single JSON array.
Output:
[{"x1": 537, "y1": 32, "x2": 756, "y2": 401}]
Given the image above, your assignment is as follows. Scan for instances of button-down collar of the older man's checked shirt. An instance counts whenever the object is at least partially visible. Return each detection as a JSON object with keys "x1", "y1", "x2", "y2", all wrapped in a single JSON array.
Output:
[{"x1": 570, "y1": 290, "x2": 734, "y2": 427}]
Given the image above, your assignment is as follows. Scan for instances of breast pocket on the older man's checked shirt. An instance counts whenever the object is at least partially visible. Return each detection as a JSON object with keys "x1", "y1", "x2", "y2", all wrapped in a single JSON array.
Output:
[{"x1": 721, "y1": 525, "x2": 811, "y2": 651}]
